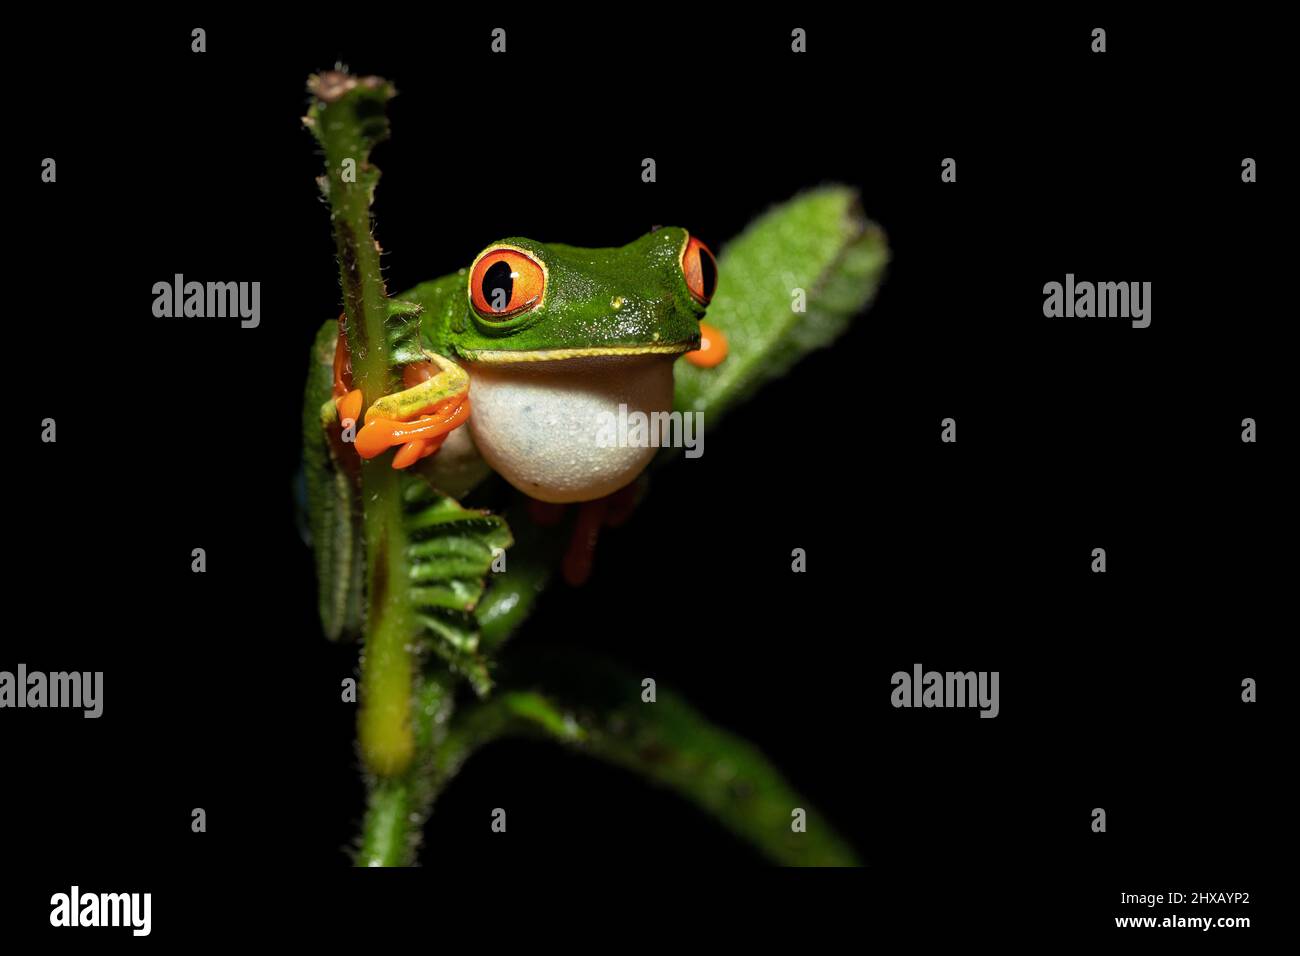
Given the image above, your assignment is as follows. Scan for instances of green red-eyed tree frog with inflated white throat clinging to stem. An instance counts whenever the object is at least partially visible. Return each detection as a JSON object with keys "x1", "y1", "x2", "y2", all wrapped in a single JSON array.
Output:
[{"x1": 304, "y1": 226, "x2": 725, "y2": 606}]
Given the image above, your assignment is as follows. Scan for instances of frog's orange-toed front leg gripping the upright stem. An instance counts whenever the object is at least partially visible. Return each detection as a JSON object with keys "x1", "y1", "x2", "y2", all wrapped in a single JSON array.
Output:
[{"x1": 334, "y1": 323, "x2": 469, "y2": 468}]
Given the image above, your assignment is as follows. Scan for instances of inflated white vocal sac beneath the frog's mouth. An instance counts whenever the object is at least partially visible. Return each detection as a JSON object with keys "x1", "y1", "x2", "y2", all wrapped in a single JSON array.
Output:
[{"x1": 469, "y1": 355, "x2": 677, "y2": 503}]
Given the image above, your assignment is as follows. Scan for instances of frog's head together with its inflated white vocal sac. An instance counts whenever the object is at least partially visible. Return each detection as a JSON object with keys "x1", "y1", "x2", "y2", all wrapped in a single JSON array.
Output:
[{"x1": 450, "y1": 228, "x2": 718, "y2": 502}]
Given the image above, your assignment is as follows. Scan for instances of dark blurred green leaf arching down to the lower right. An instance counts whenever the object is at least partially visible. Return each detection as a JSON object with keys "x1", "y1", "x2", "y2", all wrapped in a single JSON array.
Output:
[{"x1": 434, "y1": 658, "x2": 858, "y2": 866}]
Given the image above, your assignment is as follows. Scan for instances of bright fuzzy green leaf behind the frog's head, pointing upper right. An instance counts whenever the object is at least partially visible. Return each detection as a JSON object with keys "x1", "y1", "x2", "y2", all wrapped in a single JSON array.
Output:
[{"x1": 675, "y1": 186, "x2": 889, "y2": 421}]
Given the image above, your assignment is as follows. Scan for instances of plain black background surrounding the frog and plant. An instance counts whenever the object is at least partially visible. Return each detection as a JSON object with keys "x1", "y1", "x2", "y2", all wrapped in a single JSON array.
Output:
[{"x1": 0, "y1": 9, "x2": 1294, "y2": 942}]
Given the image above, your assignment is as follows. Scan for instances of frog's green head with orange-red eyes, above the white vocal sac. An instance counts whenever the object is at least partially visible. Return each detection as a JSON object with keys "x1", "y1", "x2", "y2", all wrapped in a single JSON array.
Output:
[{"x1": 451, "y1": 228, "x2": 718, "y2": 364}]
